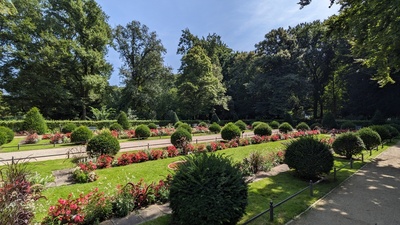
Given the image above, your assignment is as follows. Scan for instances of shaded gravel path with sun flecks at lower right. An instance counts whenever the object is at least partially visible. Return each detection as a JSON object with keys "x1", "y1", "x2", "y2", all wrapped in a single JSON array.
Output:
[{"x1": 287, "y1": 142, "x2": 400, "y2": 225}]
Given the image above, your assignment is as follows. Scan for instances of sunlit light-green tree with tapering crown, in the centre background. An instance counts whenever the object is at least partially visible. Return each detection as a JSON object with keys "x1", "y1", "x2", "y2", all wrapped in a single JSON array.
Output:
[{"x1": 177, "y1": 46, "x2": 228, "y2": 118}]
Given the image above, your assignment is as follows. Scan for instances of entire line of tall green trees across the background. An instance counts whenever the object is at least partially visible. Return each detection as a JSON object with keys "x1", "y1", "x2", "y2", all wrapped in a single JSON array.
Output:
[{"x1": 0, "y1": 0, "x2": 400, "y2": 120}]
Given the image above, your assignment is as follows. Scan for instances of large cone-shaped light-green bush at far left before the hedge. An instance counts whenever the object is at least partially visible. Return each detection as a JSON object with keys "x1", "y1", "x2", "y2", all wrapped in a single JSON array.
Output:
[{"x1": 23, "y1": 107, "x2": 47, "y2": 134}]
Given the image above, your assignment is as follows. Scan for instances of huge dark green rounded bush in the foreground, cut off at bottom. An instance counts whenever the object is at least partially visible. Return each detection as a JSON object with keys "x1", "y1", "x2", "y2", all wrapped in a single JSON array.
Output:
[{"x1": 169, "y1": 153, "x2": 248, "y2": 225}]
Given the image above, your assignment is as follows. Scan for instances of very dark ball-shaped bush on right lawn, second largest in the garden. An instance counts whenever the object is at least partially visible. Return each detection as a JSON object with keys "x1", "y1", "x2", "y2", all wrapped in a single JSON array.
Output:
[{"x1": 284, "y1": 136, "x2": 333, "y2": 179}]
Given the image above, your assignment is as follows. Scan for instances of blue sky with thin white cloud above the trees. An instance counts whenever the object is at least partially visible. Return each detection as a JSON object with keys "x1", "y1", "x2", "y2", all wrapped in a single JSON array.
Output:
[{"x1": 97, "y1": 0, "x2": 339, "y2": 86}]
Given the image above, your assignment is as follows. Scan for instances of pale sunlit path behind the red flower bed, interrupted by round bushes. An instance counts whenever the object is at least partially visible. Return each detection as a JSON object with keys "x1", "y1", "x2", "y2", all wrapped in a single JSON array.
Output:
[{"x1": 0, "y1": 132, "x2": 254, "y2": 165}]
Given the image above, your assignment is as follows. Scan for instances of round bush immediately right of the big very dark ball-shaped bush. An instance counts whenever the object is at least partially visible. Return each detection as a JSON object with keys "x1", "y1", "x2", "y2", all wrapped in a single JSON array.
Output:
[{"x1": 332, "y1": 132, "x2": 365, "y2": 159}]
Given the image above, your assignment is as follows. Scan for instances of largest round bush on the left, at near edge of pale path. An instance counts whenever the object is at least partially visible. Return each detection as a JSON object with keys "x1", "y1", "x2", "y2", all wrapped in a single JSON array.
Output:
[{"x1": 86, "y1": 132, "x2": 120, "y2": 157}]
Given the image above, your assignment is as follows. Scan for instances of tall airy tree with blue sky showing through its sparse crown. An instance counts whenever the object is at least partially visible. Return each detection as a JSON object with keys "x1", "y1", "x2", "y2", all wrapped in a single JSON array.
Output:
[{"x1": 114, "y1": 21, "x2": 172, "y2": 118}]
